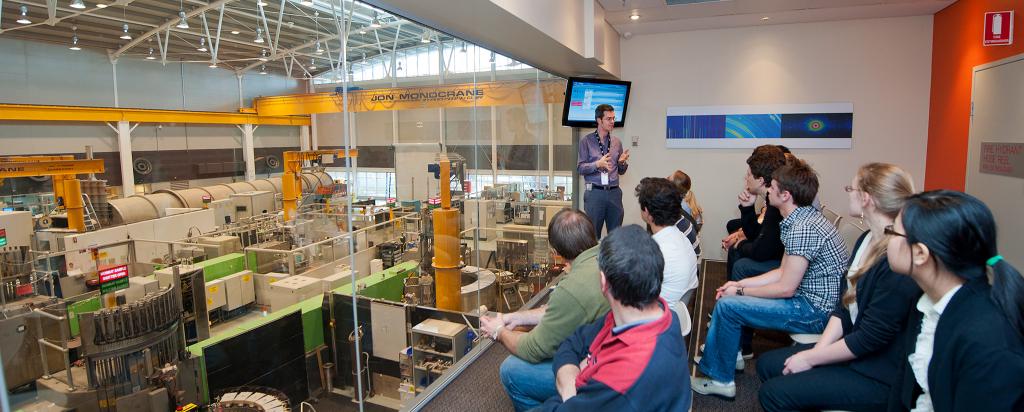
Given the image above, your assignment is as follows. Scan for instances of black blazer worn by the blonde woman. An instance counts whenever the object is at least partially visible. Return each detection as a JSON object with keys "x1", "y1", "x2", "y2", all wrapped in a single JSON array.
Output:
[{"x1": 833, "y1": 233, "x2": 922, "y2": 385}]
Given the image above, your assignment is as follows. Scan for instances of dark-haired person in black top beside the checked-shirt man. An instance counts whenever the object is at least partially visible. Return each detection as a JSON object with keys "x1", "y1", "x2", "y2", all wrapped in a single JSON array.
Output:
[{"x1": 722, "y1": 145, "x2": 785, "y2": 356}]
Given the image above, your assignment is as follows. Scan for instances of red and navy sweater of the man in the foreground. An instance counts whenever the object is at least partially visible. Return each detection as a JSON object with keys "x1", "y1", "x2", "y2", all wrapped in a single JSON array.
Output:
[{"x1": 542, "y1": 299, "x2": 691, "y2": 412}]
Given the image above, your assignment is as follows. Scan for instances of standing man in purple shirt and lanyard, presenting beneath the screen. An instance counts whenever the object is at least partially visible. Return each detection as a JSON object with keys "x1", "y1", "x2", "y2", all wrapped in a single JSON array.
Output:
[{"x1": 577, "y1": 105, "x2": 630, "y2": 238}]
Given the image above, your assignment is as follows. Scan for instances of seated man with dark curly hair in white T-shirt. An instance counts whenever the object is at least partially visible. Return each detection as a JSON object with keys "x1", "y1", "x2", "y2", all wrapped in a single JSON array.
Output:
[{"x1": 636, "y1": 177, "x2": 697, "y2": 309}]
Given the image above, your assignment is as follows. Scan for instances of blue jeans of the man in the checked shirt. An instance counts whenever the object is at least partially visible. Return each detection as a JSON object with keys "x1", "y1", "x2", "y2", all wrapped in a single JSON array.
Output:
[{"x1": 698, "y1": 296, "x2": 828, "y2": 382}]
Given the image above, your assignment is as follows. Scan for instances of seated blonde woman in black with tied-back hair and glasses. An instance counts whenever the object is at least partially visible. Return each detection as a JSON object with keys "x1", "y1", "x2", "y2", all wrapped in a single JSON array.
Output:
[{"x1": 758, "y1": 163, "x2": 921, "y2": 412}]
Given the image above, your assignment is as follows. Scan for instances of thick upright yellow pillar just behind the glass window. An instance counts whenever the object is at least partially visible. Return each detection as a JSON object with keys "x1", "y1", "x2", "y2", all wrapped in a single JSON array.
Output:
[{"x1": 433, "y1": 159, "x2": 462, "y2": 312}]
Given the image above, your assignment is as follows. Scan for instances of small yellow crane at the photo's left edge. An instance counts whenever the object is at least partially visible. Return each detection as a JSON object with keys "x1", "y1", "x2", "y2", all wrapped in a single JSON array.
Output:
[{"x1": 0, "y1": 155, "x2": 103, "y2": 232}]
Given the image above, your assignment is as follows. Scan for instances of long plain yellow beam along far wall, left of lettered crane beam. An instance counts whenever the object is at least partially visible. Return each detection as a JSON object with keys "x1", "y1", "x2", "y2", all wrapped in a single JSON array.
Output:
[{"x1": 0, "y1": 105, "x2": 310, "y2": 126}]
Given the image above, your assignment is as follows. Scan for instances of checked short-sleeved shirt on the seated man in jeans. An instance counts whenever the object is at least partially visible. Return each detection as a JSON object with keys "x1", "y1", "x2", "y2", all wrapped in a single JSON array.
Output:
[{"x1": 779, "y1": 206, "x2": 847, "y2": 313}]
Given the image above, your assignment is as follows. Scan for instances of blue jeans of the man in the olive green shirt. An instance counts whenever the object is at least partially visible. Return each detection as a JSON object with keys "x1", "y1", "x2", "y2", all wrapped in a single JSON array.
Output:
[{"x1": 501, "y1": 355, "x2": 558, "y2": 412}]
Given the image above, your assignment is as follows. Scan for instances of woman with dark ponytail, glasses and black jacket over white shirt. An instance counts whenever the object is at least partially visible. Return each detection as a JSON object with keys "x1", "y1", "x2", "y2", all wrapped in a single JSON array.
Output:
[{"x1": 886, "y1": 191, "x2": 1024, "y2": 411}]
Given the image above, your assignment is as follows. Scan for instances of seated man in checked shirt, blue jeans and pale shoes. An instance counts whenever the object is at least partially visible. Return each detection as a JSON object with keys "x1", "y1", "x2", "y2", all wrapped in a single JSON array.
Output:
[{"x1": 691, "y1": 161, "x2": 847, "y2": 399}]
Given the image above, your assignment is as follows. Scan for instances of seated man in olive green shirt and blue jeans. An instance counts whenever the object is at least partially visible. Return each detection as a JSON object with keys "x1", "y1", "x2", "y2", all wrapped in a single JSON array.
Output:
[{"x1": 480, "y1": 209, "x2": 608, "y2": 411}]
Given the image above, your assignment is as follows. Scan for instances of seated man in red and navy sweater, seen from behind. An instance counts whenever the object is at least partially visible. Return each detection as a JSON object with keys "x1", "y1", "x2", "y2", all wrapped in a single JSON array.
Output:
[{"x1": 543, "y1": 224, "x2": 691, "y2": 411}]
